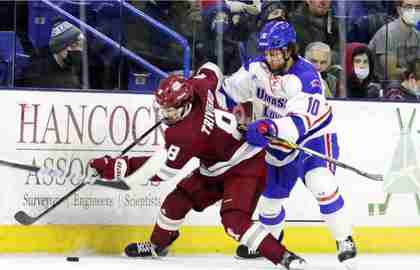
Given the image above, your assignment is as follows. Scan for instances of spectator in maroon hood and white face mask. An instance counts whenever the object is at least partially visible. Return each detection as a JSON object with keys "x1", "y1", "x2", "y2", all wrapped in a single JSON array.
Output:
[{"x1": 345, "y1": 42, "x2": 381, "y2": 98}]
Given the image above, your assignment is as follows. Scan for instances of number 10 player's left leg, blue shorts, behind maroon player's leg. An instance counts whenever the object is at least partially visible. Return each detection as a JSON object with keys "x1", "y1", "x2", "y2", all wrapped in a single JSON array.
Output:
[{"x1": 236, "y1": 161, "x2": 299, "y2": 259}]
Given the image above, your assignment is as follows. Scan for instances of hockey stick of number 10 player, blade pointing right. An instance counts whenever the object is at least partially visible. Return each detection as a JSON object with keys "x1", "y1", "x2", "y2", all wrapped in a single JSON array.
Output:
[{"x1": 239, "y1": 125, "x2": 384, "y2": 181}]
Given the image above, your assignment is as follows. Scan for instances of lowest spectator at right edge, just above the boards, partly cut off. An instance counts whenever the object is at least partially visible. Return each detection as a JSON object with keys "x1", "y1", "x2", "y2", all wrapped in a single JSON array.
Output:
[{"x1": 384, "y1": 58, "x2": 420, "y2": 101}]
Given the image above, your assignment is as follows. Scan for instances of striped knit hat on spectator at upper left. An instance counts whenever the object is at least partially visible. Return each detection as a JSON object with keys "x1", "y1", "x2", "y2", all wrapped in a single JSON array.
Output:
[{"x1": 49, "y1": 21, "x2": 81, "y2": 53}]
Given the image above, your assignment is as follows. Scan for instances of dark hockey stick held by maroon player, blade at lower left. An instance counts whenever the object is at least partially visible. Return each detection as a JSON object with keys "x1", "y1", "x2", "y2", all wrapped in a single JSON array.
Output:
[{"x1": 15, "y1": 120, "x2": 162, "y2": 225}]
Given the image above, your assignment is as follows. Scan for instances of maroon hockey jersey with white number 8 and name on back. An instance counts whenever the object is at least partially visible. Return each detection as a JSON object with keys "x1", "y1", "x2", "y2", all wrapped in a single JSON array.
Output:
[{"x1": 157, "y1": 63, "x2": 263, "y2": 180}]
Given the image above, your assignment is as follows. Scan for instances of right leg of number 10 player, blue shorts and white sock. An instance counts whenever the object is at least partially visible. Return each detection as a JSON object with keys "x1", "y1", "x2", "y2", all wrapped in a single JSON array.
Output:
[{"x1": 304, "y1": 134, "x2": 357, "y2": 269}]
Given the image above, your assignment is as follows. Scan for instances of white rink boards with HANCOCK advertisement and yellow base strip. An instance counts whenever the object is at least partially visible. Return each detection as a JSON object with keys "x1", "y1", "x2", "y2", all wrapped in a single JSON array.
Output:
[{"x1": 0, "y1": 91, "x2": 420, "y2": 254}]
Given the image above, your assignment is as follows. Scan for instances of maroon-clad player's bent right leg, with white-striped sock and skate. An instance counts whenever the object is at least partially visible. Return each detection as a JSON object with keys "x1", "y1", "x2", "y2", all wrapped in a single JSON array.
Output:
[{"x1": 220, "y1": 172, "x2": 305, "y2": 269}]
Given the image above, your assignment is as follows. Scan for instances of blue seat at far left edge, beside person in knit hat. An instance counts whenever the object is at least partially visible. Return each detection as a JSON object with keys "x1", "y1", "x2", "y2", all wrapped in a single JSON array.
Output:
[{"x1": 0, "y1": 31, "x2": 29, "y2": 86}]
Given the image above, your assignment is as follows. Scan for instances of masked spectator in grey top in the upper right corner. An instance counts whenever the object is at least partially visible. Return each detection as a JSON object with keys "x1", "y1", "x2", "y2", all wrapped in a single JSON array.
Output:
[{"x1": 369, "y1": 0, "x2": 420, "y2": 81}]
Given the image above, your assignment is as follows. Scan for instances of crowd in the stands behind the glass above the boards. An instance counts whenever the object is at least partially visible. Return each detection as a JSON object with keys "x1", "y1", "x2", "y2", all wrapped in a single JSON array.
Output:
[{"x1": 0, "y1": 0, "x2": 420, "y2": 100}]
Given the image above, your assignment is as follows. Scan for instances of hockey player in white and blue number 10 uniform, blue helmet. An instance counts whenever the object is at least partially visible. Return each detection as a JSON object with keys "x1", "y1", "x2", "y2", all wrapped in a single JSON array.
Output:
[{"x1": 218, "y1": 21, "x2": 357, "y2": 270}]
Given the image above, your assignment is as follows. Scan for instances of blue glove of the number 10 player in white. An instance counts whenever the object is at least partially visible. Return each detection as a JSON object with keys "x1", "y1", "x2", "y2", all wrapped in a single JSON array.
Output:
[{"x1": 245, "y1": 119, "x2": 277, "y2": 147}]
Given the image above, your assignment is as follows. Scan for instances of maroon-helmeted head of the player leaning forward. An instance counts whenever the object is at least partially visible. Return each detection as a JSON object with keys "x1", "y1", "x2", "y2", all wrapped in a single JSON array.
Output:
[{"x1": 155, "y1": 75, "x2": 194, "y2": 124}]
